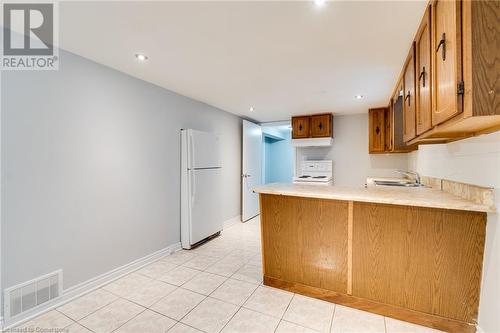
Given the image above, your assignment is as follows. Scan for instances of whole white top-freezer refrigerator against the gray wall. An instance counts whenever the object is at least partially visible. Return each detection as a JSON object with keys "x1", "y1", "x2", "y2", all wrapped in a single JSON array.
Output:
[{"x1": 181, "y1": 129, "x2": 223, "y2": 249}]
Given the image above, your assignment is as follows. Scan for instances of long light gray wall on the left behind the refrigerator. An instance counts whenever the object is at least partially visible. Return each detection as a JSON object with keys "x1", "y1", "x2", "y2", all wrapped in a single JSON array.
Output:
[{"x1": 1, "y1": 51, "x2": 241, "y2": 288}]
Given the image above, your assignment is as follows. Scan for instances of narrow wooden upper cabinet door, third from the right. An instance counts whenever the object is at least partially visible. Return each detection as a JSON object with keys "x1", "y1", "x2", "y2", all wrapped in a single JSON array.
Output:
[{"x1": 403, "y1": 43, "x2": 416, "y2": 142}]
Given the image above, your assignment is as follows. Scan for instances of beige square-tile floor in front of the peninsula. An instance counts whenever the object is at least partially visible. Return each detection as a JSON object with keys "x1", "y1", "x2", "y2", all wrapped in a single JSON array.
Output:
[{"x1": 11, "y1": 218, "x2": 444, "y2": 333}]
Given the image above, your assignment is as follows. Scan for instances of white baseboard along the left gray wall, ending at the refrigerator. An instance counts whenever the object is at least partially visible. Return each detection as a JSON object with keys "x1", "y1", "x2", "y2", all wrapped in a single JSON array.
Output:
[{"x1": 0, "y1": 243, "x2": 181, "y2": 329}]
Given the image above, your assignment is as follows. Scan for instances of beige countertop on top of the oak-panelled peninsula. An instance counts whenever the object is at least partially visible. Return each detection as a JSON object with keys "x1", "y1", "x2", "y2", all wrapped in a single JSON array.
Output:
[{"x1": 254, "y1": 183, "x2": 495, "y2": 213}]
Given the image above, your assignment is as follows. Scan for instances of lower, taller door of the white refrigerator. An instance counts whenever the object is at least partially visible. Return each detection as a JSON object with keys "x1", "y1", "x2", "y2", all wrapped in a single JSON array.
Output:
[{"x1": 189, "y1": 169, "x2": 223, "y2": 245}]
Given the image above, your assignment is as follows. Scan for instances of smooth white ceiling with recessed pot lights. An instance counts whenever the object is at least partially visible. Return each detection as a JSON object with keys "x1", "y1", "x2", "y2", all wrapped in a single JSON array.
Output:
[{"x1": 60, "y1": 1, "x2": 426, "y2": 121}]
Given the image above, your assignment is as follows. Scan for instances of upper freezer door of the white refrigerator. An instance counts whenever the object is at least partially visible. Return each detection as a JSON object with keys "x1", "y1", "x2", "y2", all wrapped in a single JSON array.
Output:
[{"x1": 188, "y1": 130, "x2": 221, "y2": 169}]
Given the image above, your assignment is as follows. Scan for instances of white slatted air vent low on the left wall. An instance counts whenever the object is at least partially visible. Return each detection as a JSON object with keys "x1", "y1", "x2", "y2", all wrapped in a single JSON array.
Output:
[{"x1": 4, "y1": 270, "x2": 62, "y2": 319}]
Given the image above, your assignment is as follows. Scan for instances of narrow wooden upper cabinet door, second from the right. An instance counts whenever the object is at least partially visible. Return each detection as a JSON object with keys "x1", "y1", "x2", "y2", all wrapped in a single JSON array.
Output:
[{"x1": 415, "y1": 7, "x2": 432, "y2": 135}]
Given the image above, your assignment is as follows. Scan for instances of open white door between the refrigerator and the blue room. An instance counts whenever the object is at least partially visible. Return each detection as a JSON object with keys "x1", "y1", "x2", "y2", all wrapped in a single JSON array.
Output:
[{"x1": 241, "y1": 120, "x2": 262, "y2": 221}]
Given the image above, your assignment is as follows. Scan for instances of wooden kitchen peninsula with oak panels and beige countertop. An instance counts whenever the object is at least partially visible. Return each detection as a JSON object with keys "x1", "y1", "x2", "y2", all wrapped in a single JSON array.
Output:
[{"x1": 255, "y1": 184, "x2": 494, "y2": 332}]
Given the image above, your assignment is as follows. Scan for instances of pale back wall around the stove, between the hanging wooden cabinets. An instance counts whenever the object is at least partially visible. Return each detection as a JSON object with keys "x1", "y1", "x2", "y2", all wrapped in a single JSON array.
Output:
[{"x1": 297, "y1": 113, "x2": 408, "y2": 186}]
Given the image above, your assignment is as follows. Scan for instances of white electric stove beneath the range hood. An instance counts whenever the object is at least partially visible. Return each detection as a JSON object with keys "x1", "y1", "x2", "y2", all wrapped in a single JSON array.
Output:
[{"x1": 293, "y1": 160, "x2": 333, "y2": 185}]
